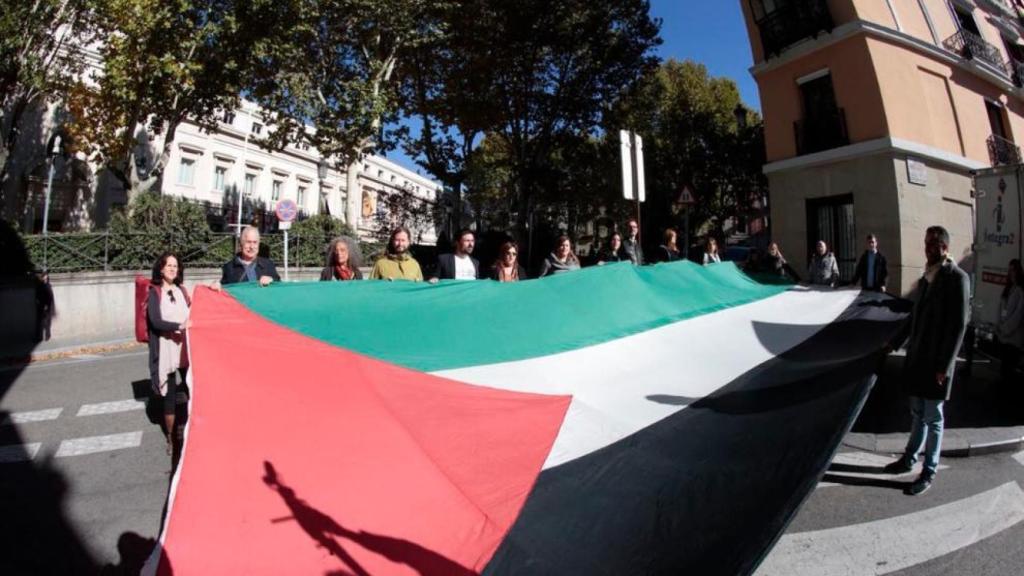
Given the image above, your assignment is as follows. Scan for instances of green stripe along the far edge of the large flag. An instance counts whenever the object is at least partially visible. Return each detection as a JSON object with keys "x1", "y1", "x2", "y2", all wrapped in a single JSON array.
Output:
[{"x1": 228, "y1": 261, "x2": 786, "y2": 368}]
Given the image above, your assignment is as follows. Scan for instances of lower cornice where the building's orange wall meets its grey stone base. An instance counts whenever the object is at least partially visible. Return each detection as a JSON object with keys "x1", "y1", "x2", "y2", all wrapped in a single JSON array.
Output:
[{"x1": 762, "y1": 136, "x2": 988, "y2": 174}]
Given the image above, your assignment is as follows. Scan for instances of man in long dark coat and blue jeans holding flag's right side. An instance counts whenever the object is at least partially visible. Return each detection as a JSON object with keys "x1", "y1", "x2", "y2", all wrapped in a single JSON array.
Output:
[{"x1": 886, "y1": 227, "x2": 971, "y2": 495}]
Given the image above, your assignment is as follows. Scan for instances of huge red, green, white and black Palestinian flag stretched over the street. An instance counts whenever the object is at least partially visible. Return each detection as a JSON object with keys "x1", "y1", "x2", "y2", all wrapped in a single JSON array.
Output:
[{"x1": 144, "y1": 262, "x2": 903, "y2": 576}]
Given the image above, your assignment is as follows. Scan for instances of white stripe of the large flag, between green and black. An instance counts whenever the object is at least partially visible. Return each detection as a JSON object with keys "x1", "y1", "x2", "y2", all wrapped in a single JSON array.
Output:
[{"x1": 435, "y1": 289, "x2": 859, "y2": 468}]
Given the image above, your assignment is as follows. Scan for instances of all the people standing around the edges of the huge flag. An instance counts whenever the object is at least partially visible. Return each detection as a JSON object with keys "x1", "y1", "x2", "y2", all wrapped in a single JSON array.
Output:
[{"x1": 146, "y1": 220, "x2": 1024, "y2": 481}]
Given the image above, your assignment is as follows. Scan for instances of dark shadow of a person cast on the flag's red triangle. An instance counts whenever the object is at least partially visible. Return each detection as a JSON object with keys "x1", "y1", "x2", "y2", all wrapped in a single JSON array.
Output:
[{"x1": 263, "y1": 461, "x2": 476, "y2": 576}]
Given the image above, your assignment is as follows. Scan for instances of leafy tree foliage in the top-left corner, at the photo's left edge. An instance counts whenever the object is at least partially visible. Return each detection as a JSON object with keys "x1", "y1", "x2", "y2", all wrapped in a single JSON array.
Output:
[{"x1": 0, "y1": 0, "x2": 92, "y2": 213}]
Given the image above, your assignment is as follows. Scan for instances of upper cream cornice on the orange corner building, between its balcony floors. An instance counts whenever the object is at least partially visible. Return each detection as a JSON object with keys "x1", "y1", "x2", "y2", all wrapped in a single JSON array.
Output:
[{"x1": 750, "y1": 20, "x2": 1022, "y2": 98}]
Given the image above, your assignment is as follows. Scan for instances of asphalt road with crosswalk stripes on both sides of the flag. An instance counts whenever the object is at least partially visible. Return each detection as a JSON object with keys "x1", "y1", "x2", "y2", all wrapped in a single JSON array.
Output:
[{"x1": 0, "y1": 351, "x2": 1024, "y2": 576}]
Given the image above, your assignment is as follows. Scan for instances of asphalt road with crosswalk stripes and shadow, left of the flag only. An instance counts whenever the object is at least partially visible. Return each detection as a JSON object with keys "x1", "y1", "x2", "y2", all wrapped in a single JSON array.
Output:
[{"x1": 0, "y1": 351, "x2": 170, "y2": 575}]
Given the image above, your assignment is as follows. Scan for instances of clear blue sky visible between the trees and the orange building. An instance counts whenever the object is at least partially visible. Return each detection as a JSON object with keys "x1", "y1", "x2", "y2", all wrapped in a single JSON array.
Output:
[{"x1": 387, "y1": 0, "x2": 761, "y2": 173}]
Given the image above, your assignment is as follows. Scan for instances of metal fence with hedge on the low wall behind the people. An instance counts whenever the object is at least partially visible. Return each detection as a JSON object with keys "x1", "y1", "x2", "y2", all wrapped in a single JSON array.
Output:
[{"x1": 22, "y1": 232, "x2": 358, "y2": 273}]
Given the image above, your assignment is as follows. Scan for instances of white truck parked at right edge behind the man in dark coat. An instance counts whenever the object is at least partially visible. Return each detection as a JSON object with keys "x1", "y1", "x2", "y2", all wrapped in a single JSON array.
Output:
[{"x1": 971, "y1": 164, "x2": 1024, "y2": 339}]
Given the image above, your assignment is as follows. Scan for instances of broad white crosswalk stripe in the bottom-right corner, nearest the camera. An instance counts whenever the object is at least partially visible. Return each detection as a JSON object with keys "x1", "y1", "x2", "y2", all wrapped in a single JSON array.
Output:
[{"x1": 756, "y1": 482, "x2": 1024, "y2": 576}]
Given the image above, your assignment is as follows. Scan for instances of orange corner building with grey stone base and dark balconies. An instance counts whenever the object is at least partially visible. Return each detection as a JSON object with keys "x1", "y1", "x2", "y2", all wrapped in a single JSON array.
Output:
[{"x1": 739, "y1": 0, "x2": 1024, "y2": 293}]
